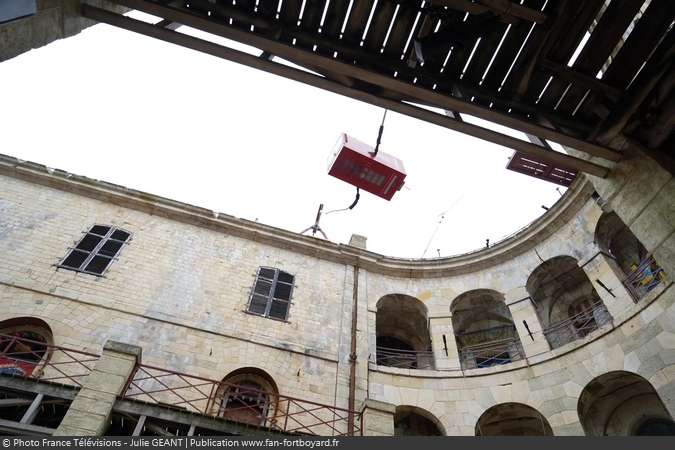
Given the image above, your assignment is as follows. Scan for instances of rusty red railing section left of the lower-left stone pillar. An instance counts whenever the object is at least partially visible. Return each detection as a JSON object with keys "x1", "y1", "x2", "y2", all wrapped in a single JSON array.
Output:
[{"x1": 0, "y1": 334, "x2": 99, "y2": 387}]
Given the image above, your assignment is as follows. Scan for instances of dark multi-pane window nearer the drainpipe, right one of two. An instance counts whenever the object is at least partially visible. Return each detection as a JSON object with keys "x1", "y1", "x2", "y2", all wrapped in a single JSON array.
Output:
[{"x1": 246, "y1": 267, "x2": 295, "y2": 320}]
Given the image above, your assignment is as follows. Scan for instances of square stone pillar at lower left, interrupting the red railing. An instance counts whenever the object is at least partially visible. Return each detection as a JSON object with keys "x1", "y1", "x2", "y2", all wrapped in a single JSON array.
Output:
[{"x1": 54, "y1": 341, "x2": 141, "y2": 436}]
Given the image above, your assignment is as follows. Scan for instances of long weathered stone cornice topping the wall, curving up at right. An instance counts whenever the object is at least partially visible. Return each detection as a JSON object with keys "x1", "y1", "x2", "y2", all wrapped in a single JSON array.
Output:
[{"x1": 0, "y1": 155, "x2": 593, "y2": 278}]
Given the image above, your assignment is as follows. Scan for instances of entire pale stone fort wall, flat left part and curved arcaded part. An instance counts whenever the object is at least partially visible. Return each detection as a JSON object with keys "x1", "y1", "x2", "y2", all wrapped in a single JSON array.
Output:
[{"x1": 0, "y1": 146, "x2": 675, "y2": 435}]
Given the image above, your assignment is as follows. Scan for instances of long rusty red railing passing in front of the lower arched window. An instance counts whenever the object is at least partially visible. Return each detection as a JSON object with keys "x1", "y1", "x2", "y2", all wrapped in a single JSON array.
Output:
[{"x1": 123, "y1": 364, "x2": 363, "y2": 436}]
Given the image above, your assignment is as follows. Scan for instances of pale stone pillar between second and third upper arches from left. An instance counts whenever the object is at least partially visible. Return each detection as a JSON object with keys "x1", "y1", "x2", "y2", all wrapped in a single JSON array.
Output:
[{"x1": 504, "y1": 287, "x2": 550, "y2": 358}]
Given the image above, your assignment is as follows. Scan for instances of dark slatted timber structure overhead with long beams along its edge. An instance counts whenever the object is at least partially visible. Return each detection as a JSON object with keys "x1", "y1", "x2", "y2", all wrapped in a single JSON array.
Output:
[{"x1": 82, "y1": 0, "x2": 675, "y2": 177}]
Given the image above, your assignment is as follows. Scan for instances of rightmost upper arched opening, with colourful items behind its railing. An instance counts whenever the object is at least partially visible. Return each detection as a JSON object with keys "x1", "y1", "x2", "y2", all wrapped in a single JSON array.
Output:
[{"x1": 595, "y1": 211, "x2": 666, "y2": 300}]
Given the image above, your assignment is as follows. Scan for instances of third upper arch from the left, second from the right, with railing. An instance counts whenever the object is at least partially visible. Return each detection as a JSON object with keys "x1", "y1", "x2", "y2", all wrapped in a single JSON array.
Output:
[{"x1": 526, "y1": 256, "x2": 612, "y2": 349}]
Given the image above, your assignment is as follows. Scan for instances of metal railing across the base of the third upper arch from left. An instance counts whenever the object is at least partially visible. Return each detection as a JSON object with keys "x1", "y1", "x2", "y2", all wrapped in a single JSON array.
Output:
[{"x1": 544, "y1": 300, "x2": 612, "y2": 348}]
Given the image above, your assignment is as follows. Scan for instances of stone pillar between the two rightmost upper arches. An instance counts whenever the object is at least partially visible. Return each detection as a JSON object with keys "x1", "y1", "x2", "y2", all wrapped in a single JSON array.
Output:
[{"x1": 579, "y1": 250, "x2": 635, "y2": 323}]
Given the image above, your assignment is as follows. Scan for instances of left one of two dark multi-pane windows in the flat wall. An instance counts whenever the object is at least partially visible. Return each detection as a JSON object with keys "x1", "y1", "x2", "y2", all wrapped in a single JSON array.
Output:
[{"x1": 59, "y1": 225, "x2": 131, "y2": 275}]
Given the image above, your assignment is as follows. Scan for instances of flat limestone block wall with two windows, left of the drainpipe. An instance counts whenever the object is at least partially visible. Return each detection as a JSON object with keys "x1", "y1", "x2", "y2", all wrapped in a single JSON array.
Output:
[{"x1": 0, "y1": 162, "x2": 360, "y2": 407}]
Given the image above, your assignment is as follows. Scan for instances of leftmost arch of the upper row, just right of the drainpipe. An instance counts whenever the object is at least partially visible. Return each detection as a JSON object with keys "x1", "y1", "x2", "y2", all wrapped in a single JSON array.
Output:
[{"x1": 375, "y1": 294, "x2": 435, "y2": 369}]
